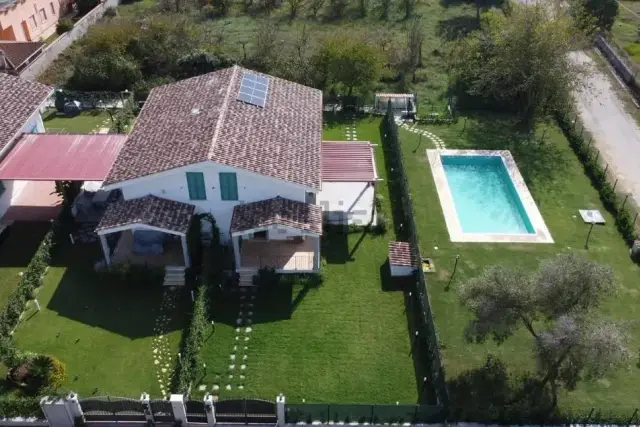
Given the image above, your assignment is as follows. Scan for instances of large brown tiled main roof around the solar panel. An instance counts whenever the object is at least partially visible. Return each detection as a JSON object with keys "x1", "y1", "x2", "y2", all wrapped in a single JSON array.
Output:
[{"x1": 105, "y1": 66, "x2": 322, "y2": 189}]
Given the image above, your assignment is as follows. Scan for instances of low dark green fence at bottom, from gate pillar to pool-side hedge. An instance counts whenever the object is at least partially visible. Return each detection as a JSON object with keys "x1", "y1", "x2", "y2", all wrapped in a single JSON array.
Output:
[{"x1": 285, "y1": 403, "x2": 444, "y2": 424}]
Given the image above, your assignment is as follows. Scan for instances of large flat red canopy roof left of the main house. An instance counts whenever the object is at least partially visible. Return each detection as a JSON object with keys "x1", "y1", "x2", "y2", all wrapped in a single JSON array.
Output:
[{"x1": 0, "y1": 133, "x2": 127, "y2": 181}]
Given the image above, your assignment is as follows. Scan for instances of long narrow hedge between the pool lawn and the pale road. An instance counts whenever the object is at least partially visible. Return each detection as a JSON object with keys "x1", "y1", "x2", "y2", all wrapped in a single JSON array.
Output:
[{"x1": 556, "y1": 111, "x2": 638, "y2": 245}]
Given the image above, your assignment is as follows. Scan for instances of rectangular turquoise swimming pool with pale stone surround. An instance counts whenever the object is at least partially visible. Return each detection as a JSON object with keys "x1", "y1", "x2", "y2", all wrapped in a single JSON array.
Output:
[{"x1": 427, "y1": 150, "x2": 553, "y2": 243}]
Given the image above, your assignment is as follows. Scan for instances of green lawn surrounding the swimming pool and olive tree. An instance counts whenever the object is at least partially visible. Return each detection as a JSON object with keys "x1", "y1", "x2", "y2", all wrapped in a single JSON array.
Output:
[{"x1": 400, "y1": 116, "x2": 640, "y2": 416}]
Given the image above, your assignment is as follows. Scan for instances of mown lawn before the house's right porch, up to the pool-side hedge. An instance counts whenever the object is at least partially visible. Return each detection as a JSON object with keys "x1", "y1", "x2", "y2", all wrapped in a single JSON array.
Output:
[{"x1": 201, "y1": 117, "x2": 417, "y2": 403}]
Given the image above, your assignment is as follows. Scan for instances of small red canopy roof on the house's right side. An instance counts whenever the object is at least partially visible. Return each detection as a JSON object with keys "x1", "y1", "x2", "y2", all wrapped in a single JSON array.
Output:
[{"x1": 322, "y1": 141, "x2": 378, "y2": 182}]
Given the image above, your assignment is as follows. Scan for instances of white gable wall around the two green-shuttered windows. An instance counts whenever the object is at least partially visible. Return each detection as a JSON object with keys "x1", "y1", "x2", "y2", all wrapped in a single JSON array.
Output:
[{"x1": 119, "y1": 162, "x2": 314, "y2": 241}]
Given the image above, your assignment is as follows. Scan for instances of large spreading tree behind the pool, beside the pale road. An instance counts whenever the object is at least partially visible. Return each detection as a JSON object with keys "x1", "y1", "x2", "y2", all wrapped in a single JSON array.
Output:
[{"x1": 448, "y1": 2, "x2": 584, "y2": 126}]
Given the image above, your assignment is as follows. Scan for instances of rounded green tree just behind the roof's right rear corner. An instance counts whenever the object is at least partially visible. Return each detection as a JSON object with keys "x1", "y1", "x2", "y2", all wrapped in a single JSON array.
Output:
[{"x1": 312, "y1": 33, "x2": 382, "y2": 95}]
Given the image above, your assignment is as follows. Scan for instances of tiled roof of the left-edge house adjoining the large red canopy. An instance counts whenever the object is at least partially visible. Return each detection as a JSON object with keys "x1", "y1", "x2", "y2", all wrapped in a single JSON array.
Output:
[{"x1": 0, "y1": 73, "x2": 53, "y2": 154}]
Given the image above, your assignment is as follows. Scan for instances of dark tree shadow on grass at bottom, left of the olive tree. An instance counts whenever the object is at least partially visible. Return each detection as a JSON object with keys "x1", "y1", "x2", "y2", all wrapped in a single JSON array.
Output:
[{"x1": 447, "y1": 356, "x2": 559, "y2": 424}]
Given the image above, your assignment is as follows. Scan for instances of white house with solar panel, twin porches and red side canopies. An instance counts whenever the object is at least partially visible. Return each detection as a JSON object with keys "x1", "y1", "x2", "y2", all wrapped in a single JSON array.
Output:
[{"x1": 0, "y1": 66, "x2": 378, "y2": 284}]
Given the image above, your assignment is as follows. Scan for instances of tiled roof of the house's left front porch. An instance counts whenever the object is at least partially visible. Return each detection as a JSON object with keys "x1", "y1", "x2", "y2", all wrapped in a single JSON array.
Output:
[{"x1": 96, "y1": 196, "x2": 195, "y2": 234}]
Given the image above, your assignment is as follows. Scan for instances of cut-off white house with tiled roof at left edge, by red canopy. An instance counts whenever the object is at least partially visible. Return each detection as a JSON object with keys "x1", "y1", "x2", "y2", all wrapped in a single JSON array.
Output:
[{"x1": 0, "y1": 73, "x2": 53, "y2": 230}]
